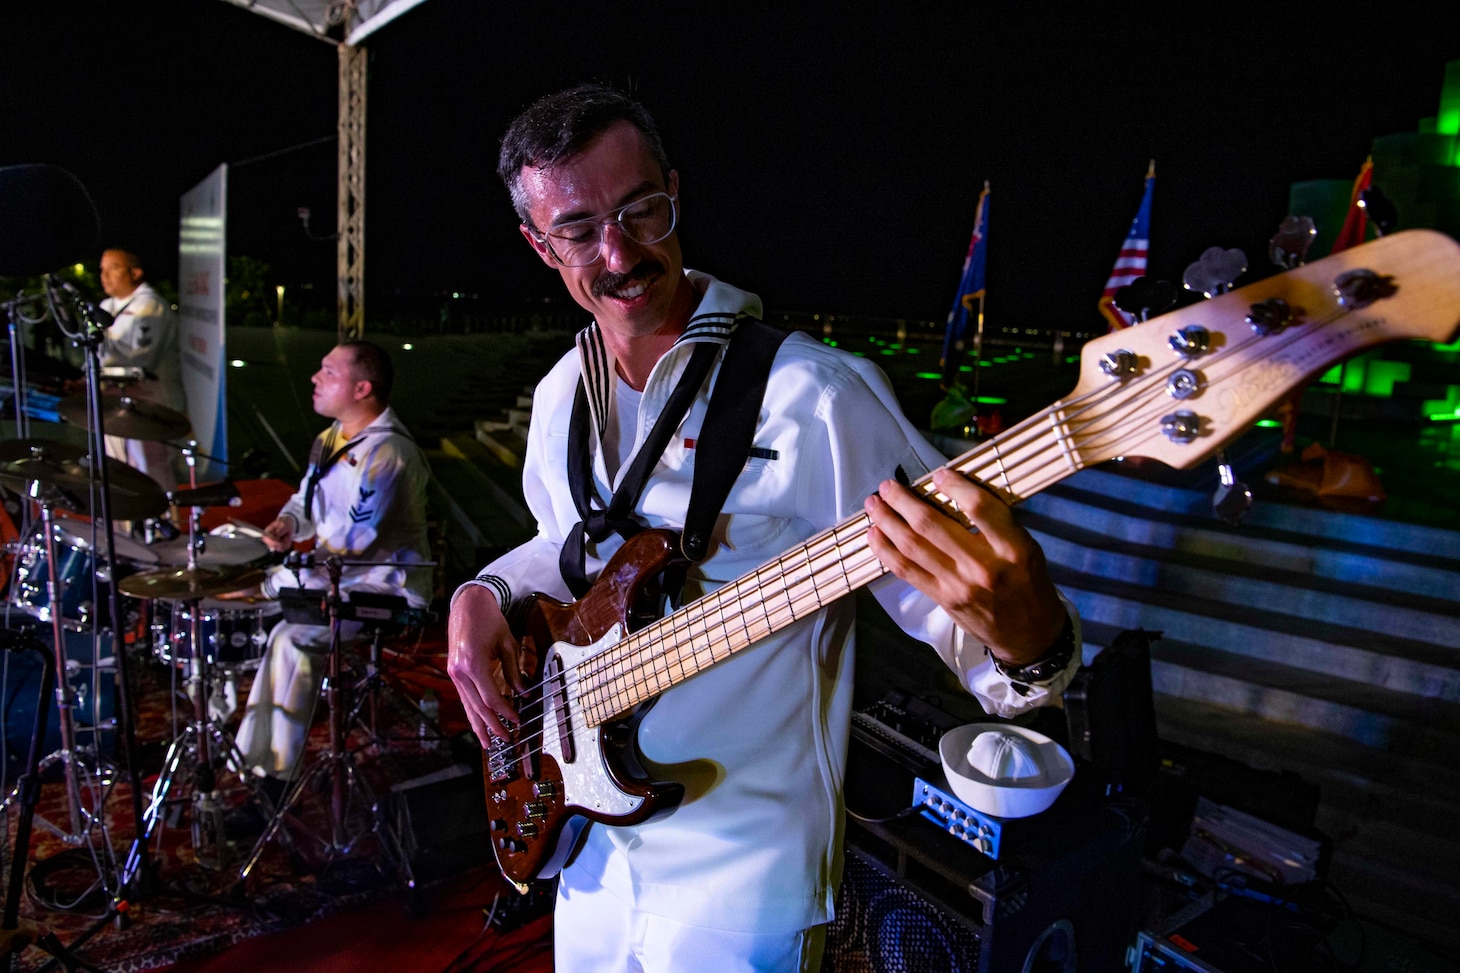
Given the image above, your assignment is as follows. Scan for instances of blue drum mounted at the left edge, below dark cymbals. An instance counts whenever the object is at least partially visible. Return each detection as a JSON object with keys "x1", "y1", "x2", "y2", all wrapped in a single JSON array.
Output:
[{"x1": 6, "y1": 523, "x2": 156, "y2": 628}]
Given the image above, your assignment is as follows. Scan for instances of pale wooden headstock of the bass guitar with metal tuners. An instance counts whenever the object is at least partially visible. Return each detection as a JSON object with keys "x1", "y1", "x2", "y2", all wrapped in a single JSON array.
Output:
[{"x1": 1053, "y1": 229, "x2": 1460, "y2": 468}]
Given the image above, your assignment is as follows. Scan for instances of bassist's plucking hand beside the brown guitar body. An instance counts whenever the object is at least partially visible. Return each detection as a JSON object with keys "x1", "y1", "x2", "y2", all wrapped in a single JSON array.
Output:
[{"x1": 447, "y1": 584, "x2": 526, "y2": 747}]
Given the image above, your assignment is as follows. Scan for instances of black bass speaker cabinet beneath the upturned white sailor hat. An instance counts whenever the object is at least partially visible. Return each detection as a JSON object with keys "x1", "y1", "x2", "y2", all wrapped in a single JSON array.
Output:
[{"x1": 822, "y1": 774, "x2": 1148, "y2": 973}]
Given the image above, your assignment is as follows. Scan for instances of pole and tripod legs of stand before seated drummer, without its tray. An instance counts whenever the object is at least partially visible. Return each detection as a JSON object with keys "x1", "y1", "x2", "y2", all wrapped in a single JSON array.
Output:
[{"x1": 238, "y1": 555, "x2": 404, "y2": 887}]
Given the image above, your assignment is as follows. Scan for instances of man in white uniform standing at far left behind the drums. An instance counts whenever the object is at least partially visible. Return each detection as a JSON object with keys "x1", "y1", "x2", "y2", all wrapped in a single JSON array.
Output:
[{"x1": 101, "y1": 248, "x2": 187, "y2": 491}]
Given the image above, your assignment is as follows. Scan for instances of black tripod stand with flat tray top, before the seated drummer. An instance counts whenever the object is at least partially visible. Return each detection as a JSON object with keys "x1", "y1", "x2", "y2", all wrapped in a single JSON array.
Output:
[{"x1": 238, "y1": 554, "x2": 432, "y2": 888}]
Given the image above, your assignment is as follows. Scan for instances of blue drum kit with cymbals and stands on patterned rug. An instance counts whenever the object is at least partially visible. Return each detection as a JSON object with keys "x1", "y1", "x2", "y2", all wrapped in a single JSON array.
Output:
[{"x1": 0, "y1": 371, "x2": 279, "y2": 890}]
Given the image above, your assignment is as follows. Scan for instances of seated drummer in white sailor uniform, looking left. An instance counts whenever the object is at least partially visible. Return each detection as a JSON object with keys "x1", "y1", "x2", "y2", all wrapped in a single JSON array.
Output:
[{"x1": 219, "y1": 342, "x2": 431, "y2": 804}]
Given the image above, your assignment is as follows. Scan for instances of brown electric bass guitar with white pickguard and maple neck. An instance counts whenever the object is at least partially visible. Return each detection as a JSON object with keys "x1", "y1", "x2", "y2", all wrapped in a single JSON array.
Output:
[{"x1": 483, "y1": 229, "x2": 1460, "y2": 890}]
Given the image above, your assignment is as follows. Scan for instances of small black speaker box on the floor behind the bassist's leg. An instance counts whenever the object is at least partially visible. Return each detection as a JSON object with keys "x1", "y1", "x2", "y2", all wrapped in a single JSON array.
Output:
[{"x1": 390, "y1": 764, "x2": 492, "y2": 884}]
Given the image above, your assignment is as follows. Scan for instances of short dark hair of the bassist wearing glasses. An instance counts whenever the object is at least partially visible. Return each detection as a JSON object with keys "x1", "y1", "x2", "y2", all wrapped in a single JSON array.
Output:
[{"x1": 496, "y1": 85, "x2": 669, "y2": 225}]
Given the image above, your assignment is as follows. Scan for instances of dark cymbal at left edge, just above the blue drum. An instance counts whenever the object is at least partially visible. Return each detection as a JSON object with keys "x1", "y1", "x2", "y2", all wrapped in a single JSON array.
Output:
[{"x1": 0, "y1": 440, "x2": 168, "y2": 520}]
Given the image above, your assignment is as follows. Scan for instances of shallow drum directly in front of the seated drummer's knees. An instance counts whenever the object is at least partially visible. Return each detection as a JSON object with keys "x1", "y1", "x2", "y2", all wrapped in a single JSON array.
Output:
[{"x1": 152, "y1": 598, "x2": 283, "y2": 672}]
